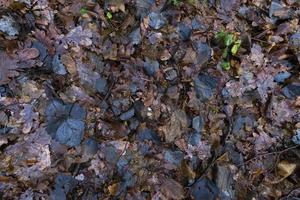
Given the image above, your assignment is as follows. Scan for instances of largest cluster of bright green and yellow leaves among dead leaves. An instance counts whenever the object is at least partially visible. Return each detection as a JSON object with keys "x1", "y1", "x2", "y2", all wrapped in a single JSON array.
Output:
[{"x1": 215, "y1": 31, "x2": 242, "y2": 70}]
